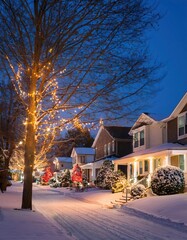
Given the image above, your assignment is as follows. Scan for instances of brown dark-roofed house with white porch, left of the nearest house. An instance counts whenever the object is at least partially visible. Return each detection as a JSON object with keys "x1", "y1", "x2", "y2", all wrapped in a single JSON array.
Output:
[{"x1": 81, "y1": 124, "x2": 132, "y2": 181}]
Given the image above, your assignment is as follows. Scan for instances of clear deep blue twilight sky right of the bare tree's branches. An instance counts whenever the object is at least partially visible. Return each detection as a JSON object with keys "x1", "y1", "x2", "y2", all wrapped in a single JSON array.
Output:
[{"x1": 144, "y1": 0, "x2": 187, "y2": 120}]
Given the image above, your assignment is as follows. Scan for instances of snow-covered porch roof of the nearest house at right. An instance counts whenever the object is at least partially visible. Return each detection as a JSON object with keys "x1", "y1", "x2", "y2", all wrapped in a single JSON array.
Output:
[{"x1": 114, "y1": 143, "x2": 187, "y2": 160}]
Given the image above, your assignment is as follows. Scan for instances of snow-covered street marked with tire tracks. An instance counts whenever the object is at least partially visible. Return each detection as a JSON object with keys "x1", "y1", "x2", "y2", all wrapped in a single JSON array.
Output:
[{"x1": 32, "y1": 190, "x2": 186, "y2": 240}]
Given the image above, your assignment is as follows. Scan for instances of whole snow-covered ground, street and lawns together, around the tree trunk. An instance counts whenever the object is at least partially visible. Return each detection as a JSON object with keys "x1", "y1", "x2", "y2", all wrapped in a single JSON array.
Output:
[{"x1": 0, "y1": 183, "x2": 187, "y2": 240}]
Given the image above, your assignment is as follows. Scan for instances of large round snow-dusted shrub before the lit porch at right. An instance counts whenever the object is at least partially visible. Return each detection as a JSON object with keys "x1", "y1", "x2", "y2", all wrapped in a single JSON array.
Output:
[{"x1": 151, "y1": 166, "x2": 185, "y2": 195}]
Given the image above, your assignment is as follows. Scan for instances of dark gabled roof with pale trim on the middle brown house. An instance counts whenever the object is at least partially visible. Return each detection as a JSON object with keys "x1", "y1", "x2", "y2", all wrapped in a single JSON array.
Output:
[{"x1": 92, "y1": 125, "x2": 131, "y2": 147}]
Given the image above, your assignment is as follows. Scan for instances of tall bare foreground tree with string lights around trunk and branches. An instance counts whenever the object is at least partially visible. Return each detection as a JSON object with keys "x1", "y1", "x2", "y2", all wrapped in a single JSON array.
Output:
[{"x1": 0, "y1": 0, "x2": 159, "y2": 209}]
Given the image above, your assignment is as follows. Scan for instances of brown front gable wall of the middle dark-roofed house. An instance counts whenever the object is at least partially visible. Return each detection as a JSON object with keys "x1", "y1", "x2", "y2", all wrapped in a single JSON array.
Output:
[{"x1": 95, "y1": 129, "x2": 113, "y2": 160}]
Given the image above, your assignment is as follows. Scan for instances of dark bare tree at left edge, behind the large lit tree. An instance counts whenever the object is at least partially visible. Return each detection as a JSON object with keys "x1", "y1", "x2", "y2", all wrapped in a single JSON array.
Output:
[{"x1": 0, "y1": 80, "x2": 23, "y2": 190}]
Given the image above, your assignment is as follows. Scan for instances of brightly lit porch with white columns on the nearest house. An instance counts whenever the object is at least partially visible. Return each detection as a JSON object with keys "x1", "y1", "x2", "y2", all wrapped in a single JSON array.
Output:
[{"x1": 114, "y1": 144, "x2": 187, "y2": 185}]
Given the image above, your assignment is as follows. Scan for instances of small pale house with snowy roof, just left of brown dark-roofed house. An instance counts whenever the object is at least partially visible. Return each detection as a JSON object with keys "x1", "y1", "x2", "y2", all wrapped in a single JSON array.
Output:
[{"x1": 71, "y1": 147, "x2": 95, "y2": 181}]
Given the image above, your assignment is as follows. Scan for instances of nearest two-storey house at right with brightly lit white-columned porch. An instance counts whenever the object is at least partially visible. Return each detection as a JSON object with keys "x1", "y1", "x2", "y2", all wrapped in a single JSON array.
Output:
[{"x1": 114, "y1": 93, "x2": 187, "y2": 185}]
